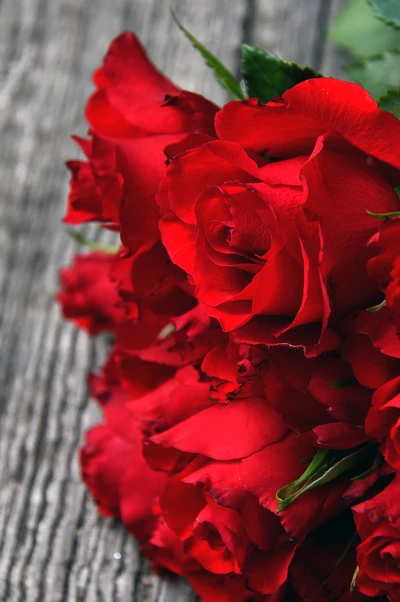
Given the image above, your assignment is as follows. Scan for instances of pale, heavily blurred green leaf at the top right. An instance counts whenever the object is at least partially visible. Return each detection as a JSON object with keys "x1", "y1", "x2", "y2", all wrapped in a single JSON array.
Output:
[{"x1": 329, "y1": 0, "x2": 400, "y2": 59}]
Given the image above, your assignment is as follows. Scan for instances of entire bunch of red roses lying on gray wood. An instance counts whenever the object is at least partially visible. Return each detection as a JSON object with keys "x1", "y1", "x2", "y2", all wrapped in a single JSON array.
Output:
[{"x1": 58, "y1": 33, "x2": 400, "y2": 602}]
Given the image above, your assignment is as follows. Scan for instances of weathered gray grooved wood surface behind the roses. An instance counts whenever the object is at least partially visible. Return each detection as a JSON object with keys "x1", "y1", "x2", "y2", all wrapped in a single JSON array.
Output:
[{"x1": 0, "y1": 0, "x2": 343, "y2": 602}]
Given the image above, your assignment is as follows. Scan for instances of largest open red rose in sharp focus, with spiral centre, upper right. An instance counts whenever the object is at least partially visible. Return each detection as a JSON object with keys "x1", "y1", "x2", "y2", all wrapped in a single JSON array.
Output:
[{"x1": 158, "y1": 78, "x2": 400, "y2": 348}]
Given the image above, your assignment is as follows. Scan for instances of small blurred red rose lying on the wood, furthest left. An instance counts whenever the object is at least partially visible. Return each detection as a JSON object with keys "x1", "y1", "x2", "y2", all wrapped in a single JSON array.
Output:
[{"x1": 57, "y1": 252, "x2": 124, "y2": 335}]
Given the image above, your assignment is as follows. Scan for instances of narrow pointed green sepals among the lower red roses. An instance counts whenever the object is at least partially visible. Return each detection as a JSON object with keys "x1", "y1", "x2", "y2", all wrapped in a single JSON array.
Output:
[{"x1": 276, "y1": 445, "x2": 371, "y2": 512}]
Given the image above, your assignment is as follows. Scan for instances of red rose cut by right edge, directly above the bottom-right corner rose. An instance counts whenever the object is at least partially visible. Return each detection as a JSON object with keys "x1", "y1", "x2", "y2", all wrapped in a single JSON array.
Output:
[{"x1": 365, "y1": 377, "x2": 400, "y2": 470}]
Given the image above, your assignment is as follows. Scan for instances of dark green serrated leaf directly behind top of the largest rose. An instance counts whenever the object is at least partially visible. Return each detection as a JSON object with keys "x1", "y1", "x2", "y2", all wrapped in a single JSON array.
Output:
[{"x1": 242, "y1": 44, "x2": 321, "y2": 102}]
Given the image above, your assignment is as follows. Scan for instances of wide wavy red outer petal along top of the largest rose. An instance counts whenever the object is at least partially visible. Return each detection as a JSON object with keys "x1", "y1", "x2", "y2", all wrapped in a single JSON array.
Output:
[{"x1": 216, "y1": 78, "x2": 400, "y2": 168}]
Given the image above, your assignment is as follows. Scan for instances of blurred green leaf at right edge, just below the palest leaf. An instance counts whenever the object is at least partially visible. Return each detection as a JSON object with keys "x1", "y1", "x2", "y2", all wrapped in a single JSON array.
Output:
[{"x1": 345, "y1": 49, "x2": 400, "y2": 99}]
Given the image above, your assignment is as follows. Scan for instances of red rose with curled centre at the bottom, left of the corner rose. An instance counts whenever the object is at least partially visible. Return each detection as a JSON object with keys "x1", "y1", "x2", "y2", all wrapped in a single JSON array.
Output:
[{"x1": 160, "y1": 457, "x2": 296, "y2": 594}]
